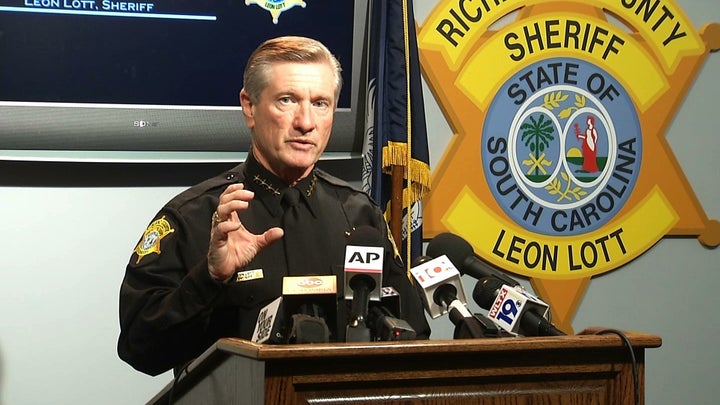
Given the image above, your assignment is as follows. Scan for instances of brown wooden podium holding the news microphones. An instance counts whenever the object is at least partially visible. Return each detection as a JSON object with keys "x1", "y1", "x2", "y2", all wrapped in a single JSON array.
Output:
[{"x1": 149, "y1": 331, "x2": 662, "y2": 405}]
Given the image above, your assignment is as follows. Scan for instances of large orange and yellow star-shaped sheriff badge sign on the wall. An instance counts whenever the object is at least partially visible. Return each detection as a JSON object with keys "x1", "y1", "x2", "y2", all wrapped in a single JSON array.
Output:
[{"x1": 418, "y1": 0, "x2": 720, "y2": 331}]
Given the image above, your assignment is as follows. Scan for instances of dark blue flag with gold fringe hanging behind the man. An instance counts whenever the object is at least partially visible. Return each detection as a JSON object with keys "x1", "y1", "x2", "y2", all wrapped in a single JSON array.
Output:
[{"x1": 363, "y1": 0, "x2": 430, "y2": 268}]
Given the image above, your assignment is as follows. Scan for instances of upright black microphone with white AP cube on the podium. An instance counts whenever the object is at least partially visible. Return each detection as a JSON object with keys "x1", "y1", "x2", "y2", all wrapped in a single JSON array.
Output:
[{"x1": 344, "y1": 226, "x2": 385, "y2": 342}]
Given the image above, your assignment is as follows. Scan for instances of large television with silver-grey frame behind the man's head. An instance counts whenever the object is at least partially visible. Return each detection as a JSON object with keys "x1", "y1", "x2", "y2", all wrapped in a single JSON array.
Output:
[{"x1": 0, "y1": 0, "x2": 367, "y2": 162}]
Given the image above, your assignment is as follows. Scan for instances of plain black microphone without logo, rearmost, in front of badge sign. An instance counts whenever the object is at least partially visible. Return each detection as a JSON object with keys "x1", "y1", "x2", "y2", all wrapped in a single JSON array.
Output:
[{"x1": 426, "y1": 232, "x2": 520, "y2": 287}]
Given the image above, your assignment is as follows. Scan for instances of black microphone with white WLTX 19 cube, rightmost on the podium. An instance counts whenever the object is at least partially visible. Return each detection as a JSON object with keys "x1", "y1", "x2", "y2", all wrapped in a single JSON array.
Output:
[{"x1": 473, "y1": 277, "x2": 565, "y2": 336}]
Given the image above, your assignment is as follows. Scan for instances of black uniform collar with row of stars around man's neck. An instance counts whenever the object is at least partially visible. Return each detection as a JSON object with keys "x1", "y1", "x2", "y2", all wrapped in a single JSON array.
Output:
[{"x1": 245, "y1": 151, "x2": 319, "y2": 217}]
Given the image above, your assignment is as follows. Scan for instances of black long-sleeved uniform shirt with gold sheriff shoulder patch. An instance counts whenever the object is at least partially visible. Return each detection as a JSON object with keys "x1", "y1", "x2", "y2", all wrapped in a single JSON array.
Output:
[{"x1": 118, "y1": 154, "x2": 430, "y2": 375}]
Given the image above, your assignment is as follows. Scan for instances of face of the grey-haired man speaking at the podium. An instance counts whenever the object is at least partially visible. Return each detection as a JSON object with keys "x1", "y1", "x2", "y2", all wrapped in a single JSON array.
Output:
[{"x1": 240, "y1": 63, "x2": 335, "y2": 184}]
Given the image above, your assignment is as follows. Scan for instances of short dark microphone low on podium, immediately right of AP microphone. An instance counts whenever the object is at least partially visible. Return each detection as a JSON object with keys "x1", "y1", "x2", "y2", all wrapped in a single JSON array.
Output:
[{"x1": 367, "y1": 286, "x2": 417, "y2": 341}]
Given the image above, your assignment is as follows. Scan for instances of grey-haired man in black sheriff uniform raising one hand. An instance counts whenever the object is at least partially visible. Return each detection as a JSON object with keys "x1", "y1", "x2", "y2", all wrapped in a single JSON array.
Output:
[{"x1": 118, "y1": 37, "x2": 430, "y2": 375}]
